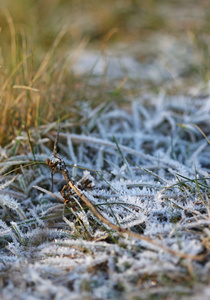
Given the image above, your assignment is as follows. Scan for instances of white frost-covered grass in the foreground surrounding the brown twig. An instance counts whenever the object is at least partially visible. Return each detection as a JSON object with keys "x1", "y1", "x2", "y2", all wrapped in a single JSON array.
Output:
[{"x1": 0, "y1": 88, "x2": 210, "y2": 299}]
